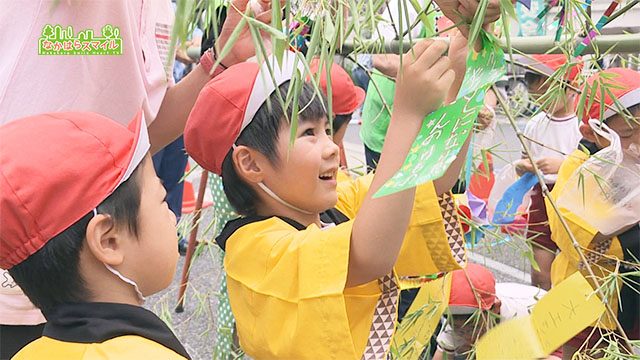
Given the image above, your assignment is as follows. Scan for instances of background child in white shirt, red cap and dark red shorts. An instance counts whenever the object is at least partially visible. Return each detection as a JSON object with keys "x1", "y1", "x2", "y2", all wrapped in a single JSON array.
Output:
[{"x1": 516, "y1": 54, "x2": 582, "y2": 290}]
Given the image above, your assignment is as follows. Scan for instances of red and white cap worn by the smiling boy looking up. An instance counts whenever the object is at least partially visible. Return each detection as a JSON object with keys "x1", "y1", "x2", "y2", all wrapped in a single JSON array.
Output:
[{"x1": 184, "y1": 52, "x2": 302, "y2": 175}]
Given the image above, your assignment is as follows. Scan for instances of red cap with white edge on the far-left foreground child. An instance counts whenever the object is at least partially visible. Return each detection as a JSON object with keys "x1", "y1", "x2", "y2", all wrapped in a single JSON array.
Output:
[{"x1": 0, "y1": 112, "x2": 149, "y2": 269}]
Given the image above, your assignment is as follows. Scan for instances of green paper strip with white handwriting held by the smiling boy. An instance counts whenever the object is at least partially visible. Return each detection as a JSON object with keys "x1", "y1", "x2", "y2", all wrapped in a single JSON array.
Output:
[{"x1": 374, "y1": 38, "x2": 506, "y2": 198}]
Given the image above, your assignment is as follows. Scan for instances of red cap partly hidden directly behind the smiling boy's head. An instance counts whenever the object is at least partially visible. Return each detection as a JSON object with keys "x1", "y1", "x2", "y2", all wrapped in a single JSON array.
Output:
[{"x1": 309, "y1": 59, "x2": 365, "y2": 115}]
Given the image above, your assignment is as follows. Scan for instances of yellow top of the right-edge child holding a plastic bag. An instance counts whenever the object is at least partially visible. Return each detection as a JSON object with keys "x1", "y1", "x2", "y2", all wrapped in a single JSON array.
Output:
[{"x1": 546, "y1": 150, "x2": 623, "y2": 329}]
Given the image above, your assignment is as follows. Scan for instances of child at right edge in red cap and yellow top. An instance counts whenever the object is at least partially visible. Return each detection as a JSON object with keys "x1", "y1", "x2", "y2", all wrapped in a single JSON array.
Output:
[{"x1": 547, "y1": 68, "x2": 640, "y2": 356}]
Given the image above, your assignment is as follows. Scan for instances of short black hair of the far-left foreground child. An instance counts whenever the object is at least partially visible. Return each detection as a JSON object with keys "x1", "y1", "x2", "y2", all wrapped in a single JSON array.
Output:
[{"x1": 9, "y1": 157, "x2": 145, "y2": 316}]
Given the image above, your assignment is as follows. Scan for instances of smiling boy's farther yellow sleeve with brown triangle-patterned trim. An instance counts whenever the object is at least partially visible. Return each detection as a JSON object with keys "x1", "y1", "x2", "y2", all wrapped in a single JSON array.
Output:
[{"x1": 336, "y1": 174, "x2": 465, "y2": 277}]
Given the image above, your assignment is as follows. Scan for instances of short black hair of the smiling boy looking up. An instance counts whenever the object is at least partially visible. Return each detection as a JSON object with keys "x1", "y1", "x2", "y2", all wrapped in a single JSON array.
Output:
[{"x1": 222, "y1": 82, "x2": 327, "y2": 216}]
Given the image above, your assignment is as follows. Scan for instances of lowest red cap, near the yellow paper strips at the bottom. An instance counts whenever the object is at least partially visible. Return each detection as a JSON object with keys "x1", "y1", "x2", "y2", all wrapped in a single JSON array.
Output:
[{"x1": 449, "y1": 263, "x2": 496, "y2": 315}]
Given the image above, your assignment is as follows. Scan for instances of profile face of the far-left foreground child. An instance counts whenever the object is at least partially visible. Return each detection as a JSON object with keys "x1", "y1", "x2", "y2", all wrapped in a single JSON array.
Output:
[{"x1": 125, "y1": 158, "x2": 180, "y2": 296}]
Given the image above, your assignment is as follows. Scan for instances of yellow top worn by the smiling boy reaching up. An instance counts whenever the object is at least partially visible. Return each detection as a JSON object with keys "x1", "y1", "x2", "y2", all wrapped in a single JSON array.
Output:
[{"x1": 224, "y1": 175, "x2": 464, "y2": 359}]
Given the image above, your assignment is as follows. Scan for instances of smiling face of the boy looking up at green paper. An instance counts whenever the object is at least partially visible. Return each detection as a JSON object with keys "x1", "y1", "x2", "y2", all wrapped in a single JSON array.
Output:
[{"x1": 264, "y1": 117, "x2": 340, "y2": 213}]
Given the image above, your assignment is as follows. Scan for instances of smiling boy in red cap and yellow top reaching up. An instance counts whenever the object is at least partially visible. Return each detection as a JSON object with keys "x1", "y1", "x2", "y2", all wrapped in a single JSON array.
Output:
[{"x1": 185, "y1": 41, "x2": 465, "y2": 359}]
